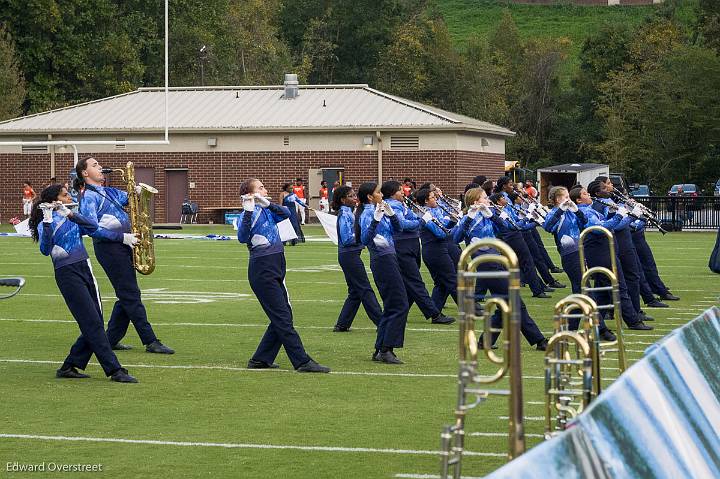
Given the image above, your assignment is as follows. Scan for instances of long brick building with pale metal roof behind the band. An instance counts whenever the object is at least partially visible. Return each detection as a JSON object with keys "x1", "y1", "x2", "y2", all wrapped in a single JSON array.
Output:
[{"x1": 0, "y1": 84, "x2": 514, "y2": 223}]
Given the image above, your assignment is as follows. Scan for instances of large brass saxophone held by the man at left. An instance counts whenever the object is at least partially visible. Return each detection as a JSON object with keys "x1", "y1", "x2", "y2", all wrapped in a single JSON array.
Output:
[{"x1": 113, "y1": 161, "x2": 158, "y2": 274}]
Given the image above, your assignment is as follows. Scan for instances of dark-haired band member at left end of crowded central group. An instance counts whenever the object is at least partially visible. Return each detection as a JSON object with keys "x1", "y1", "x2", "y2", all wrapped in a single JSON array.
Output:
[{"x1": 332, "y1": 186, "x2": 382, "y2": 332}]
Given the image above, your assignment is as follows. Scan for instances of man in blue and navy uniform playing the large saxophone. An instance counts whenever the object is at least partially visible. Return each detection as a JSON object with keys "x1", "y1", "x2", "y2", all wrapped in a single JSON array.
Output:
[{"x1": 74, "y1": 158, "x2": 175, "y2": 354}]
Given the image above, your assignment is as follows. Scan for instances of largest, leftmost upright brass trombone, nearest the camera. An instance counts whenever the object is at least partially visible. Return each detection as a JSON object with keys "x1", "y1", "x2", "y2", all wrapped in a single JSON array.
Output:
[{"x1": 440, "y1": 238, "x2": 525, "y2": 479}]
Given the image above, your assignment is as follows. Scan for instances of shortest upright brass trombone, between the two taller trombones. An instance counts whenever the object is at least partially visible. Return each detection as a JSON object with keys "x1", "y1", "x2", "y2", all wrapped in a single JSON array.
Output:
[{"x1": 545, "y1": 294, "x2": 601, "y2": 439}]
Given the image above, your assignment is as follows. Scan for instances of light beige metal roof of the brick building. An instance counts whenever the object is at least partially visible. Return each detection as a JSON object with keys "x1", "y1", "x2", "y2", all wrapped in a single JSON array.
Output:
[{"x1": 0, "y1": 85, "x2": 515, "y2": 136}]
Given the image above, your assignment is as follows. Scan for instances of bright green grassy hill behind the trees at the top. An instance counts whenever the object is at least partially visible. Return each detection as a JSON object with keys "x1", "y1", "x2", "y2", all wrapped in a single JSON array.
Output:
[{"x1": 436, "y1": 0, "x2": 697, "y2": 78}]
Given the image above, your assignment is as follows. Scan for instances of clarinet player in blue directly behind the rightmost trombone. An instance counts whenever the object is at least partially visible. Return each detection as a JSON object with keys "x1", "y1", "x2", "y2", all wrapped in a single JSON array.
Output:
[{"x1": 577, "y1": 181, "x2": 653, "y2": 331}]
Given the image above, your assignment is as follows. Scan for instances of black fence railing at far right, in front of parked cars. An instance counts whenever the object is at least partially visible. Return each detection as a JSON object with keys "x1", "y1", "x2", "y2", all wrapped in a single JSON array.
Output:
[{"x1": 634, "y1": 196, "x2": 720, "y2": 231}]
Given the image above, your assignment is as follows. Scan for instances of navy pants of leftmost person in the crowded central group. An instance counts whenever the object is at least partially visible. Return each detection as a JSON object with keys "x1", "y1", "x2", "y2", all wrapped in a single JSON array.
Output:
[{"x1": 336, "y1": 249, "x2": 382, "y2": 328}]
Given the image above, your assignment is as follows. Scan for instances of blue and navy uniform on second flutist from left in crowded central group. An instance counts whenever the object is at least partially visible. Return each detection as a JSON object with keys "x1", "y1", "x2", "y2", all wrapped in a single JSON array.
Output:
[{"x1": 359, "y1": 204, "x2": 409, "y2": 351}]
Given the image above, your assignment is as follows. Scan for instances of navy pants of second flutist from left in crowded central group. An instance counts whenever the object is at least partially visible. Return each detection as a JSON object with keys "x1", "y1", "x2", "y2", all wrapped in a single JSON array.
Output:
[{"x1": 370, "y1": 253, "x2": 410, "y2": 350}]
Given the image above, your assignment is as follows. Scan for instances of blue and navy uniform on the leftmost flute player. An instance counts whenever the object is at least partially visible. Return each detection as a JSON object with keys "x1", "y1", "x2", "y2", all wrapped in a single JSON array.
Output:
[{"x1": 37, "y1": 211, "x2": 121, "y2": 376}]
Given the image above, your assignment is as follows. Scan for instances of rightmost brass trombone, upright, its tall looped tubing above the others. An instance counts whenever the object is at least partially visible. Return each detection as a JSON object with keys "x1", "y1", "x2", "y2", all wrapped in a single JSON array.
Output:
[{"x1": 578, "y1": 226, "x2": 628, "y2": 374}]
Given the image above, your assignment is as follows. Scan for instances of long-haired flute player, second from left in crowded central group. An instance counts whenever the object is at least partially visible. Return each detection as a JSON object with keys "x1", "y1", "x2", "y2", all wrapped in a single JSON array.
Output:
[{"x1": 355, "y1": 183, "x2": 410, "y2": 364}]
